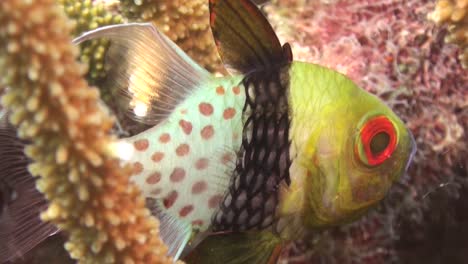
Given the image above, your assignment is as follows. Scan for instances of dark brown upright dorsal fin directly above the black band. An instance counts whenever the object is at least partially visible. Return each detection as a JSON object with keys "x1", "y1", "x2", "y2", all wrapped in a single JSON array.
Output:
[{"x1": 210, "y1": 0, "x2": 292, "y2": 74}]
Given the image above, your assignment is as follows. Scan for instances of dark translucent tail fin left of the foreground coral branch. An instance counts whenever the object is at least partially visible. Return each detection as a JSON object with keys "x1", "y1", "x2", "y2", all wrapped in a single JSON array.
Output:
[{"x1": 0, "y1": 117, "x2": 57, "y2": 263}]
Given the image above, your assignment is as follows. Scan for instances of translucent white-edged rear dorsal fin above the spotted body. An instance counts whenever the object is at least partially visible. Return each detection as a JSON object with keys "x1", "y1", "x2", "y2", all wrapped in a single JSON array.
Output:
[{"x1": 74, "y1": 23, "x2": 210, "y2": 125}]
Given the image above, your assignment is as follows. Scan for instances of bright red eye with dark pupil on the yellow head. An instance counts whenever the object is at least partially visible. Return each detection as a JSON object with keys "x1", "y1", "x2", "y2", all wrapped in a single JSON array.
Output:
[{"x1": 356, "y1": 116, "x2": 397, "y2": 166}]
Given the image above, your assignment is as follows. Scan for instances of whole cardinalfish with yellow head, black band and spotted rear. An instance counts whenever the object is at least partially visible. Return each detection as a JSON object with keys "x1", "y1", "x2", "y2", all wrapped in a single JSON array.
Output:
[{"x1": 0, "y1": 0, "x2": 415, "y2": 263}]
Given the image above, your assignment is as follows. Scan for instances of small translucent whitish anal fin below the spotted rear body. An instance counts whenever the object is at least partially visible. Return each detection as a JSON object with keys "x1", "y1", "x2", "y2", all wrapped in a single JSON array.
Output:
[{"x1": 146, "y1": 198, "x2": 192, "y2": 260}]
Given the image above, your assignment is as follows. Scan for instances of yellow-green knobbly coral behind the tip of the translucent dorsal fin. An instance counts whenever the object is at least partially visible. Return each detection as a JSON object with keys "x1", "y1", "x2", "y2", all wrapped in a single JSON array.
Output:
[{"x1": 58, "y1": 0, "x2": 123, "y2": 83}]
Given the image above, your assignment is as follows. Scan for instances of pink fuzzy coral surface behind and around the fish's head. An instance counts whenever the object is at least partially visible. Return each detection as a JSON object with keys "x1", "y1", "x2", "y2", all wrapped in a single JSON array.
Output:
[{"x1": 265, "y1": 0, "x2": 468, "y2": 263}]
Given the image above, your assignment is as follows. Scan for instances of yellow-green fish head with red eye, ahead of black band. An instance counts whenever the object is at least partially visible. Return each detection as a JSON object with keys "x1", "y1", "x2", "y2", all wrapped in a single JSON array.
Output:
[{"x1": 288, "y1": 62, "x2": 415, "y2": 227}]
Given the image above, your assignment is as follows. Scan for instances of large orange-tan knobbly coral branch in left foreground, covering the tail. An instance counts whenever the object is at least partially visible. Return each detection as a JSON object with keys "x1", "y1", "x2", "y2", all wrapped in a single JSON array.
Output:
[{"x1": 0, "y1": 0, "x2": 171, "y2": 263}]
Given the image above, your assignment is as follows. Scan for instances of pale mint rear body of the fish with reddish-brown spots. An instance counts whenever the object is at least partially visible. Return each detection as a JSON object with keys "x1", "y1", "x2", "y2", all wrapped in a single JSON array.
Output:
[{"x1": 121, "y1": 78, "x2": 245, "y2": 231}]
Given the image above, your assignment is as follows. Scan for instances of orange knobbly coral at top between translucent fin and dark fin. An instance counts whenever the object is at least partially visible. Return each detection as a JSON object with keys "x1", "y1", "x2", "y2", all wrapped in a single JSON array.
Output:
[{"x1": 120, "y1": 0, "x2": 223, "y2": 71}]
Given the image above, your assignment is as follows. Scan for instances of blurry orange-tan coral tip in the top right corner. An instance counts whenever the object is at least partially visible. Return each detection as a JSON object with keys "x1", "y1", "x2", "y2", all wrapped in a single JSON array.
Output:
[{"x1": 428, "y1": 0, "x2": 468, "y2": 68}]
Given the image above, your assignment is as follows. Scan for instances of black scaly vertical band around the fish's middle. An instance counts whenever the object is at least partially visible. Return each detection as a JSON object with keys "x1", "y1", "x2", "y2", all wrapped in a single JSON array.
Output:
[{"x1": 213, "y1": 69, "x2": 291, "y2": 231}]
